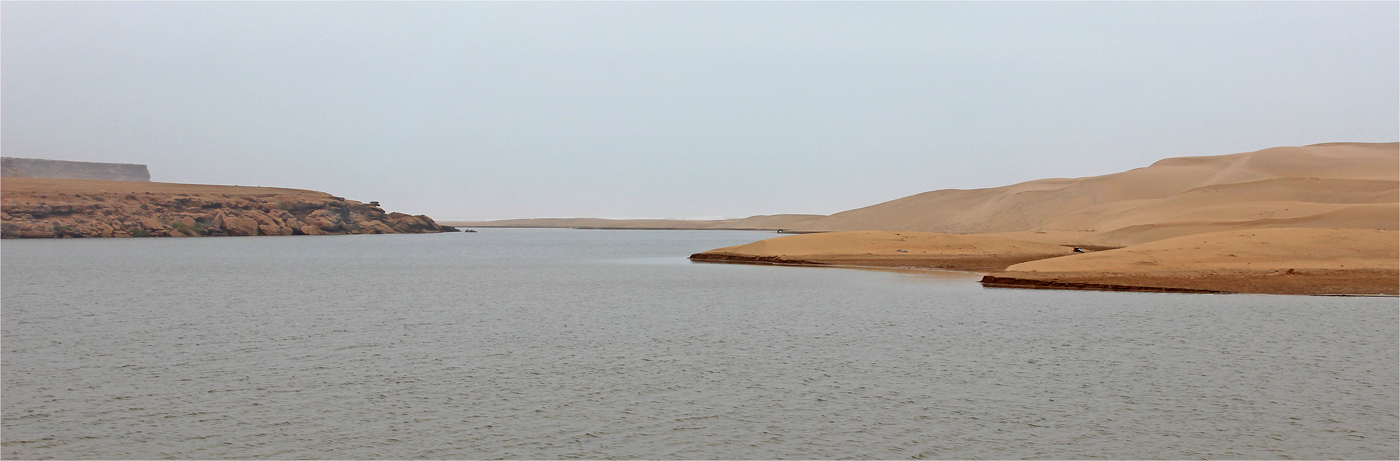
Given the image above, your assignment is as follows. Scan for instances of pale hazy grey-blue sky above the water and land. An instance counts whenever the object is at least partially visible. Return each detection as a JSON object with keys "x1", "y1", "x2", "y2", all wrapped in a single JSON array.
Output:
[{"x1": 0, "y1": 1, "x2": 1400, "y2": 220}]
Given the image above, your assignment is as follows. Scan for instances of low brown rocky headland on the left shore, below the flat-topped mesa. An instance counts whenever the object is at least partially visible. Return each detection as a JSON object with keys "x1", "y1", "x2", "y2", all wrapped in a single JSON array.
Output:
[{"x1": 0, "y1": 178, "x2": 458, "y2": 238}]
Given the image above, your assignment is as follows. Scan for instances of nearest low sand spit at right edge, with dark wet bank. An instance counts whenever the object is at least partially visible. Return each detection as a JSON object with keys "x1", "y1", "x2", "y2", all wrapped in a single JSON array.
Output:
[{"x1": 983, "y1": 228, "x2": 1400, "y2": 296}]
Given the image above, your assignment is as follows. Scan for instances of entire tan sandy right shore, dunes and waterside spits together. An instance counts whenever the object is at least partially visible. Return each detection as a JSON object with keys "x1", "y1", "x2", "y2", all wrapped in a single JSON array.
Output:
[{"x1": 692, "y1": 143, "x2": 1400, "y2": 296}]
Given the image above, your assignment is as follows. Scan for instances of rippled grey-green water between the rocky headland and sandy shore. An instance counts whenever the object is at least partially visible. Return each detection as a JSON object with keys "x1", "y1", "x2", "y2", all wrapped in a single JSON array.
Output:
[{"x1": 0, "y1": 230, "x2": 1400, "y2": 460}]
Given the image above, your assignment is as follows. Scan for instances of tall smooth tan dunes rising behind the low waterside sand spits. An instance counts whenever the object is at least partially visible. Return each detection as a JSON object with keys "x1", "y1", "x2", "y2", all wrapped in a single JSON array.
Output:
[{"x1": 794, "y1": 143, "x2": 1400, "y2": 245}]
